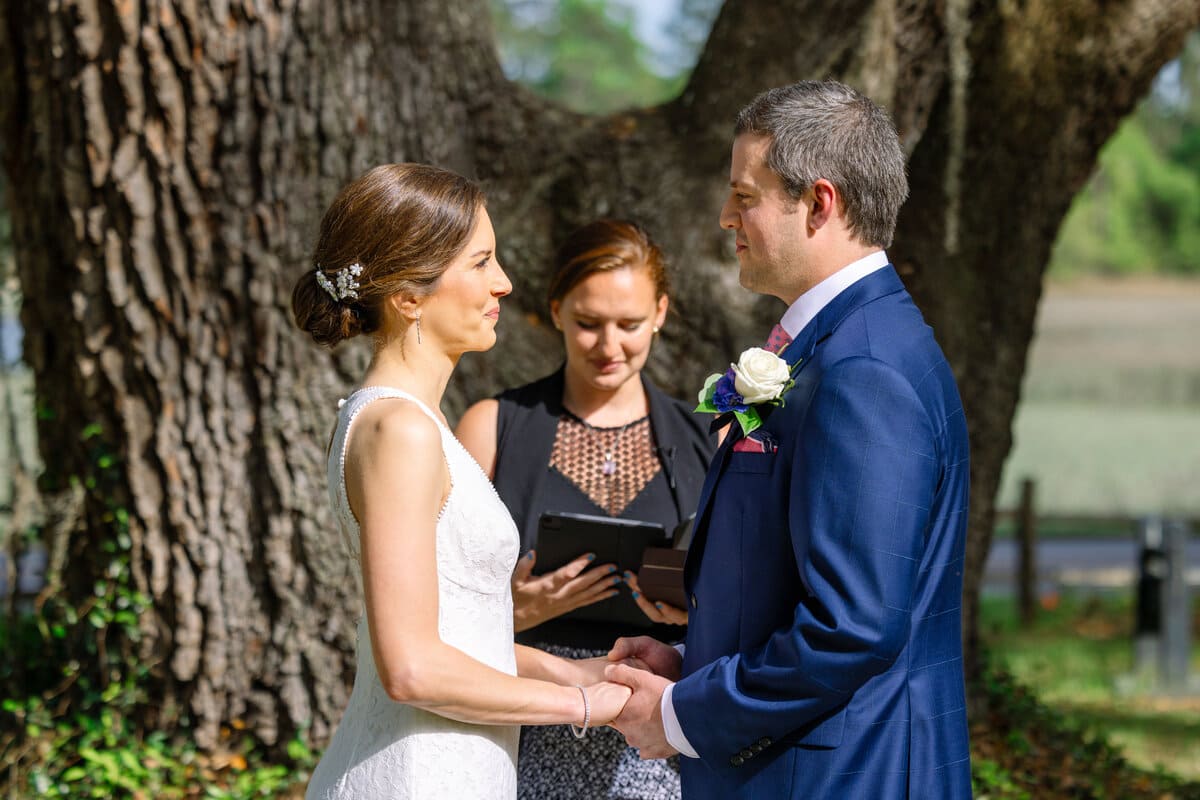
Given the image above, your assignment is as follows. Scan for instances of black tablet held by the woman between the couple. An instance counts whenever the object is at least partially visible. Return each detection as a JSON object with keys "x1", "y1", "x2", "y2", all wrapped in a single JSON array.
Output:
[{"x1": 534, "y1": 511, "x2": 671, "y2": 627}]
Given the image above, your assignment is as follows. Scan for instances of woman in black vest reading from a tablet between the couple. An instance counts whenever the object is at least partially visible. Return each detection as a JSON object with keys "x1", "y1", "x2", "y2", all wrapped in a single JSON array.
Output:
[{"x1": 456, "y1": 219, "x2": 716, "y2": 800}]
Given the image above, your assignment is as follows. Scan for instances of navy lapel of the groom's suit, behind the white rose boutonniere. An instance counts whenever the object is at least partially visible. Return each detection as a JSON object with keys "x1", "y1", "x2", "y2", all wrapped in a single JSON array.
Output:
[{"x1": 684, "y1": 264, "x2": 904, "y2": 588}]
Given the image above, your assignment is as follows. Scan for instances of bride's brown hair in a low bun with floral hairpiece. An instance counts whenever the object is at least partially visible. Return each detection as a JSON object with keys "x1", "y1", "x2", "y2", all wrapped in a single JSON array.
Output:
[{"x1": 292, "y1": 164, "x2": 485, "y2": 347}]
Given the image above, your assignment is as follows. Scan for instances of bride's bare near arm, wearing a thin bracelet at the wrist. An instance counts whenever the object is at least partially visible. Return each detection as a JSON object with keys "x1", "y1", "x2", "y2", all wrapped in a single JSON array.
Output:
[{"x1": 346, "y1": 403, "x2": 629, "y2": 724}]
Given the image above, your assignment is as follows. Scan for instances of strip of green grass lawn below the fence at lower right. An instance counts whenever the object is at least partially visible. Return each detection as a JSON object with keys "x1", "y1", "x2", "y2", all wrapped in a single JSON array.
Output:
[{"x1": 980, "y1": 594, "x2": 1200, "y2": 781}]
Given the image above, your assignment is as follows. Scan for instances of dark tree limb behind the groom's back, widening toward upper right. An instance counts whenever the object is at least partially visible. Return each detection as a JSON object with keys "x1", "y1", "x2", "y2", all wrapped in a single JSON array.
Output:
[{"x1": 892, "y1": 0, "x2": 1200, "y2": 674}]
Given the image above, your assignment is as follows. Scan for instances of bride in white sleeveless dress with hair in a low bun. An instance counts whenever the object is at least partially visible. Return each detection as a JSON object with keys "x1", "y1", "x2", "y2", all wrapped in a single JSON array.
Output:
[{"x1": 292, "y1": 164, "x2": 629, "y2": 800}]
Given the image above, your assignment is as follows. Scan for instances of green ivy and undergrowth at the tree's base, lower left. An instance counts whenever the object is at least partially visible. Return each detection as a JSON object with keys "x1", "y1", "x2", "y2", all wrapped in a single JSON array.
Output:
[{"x1": 0, "y1": 423, "x2": 314, "y2": 799}]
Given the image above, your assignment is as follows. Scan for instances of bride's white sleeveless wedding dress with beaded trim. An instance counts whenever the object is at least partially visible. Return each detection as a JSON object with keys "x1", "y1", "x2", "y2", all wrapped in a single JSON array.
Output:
[{"x1": 305, "y1": 387, "x2": 521, "y2": 800}]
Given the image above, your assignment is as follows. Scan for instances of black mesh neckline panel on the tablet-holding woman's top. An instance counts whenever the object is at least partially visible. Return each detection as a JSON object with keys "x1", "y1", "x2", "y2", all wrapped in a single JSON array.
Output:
[{"x1": 550, "y1": 413, "x2": 662, "y2": 517}]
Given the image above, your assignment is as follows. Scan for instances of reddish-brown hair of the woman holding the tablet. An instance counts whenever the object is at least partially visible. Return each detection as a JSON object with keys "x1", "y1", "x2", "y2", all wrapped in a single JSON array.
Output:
[{"x1": 547, "y1": 219, "x2": 670, "y2": 302}]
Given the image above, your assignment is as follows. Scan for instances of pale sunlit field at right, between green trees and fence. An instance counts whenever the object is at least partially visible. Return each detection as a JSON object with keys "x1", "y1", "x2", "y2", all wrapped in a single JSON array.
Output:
[{"x1": 997, "y1": 279, "x2": 1200, "y2": 520}]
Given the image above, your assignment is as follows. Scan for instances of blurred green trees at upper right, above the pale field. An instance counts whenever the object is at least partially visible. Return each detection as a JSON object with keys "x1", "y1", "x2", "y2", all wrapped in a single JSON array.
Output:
[{"x1": 1050, "y1": 32, "x2": 1200, "y2": 277}]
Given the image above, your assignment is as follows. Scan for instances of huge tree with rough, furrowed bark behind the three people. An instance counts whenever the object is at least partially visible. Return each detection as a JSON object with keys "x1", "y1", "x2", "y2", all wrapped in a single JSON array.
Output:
[{"x1": 0, "y1": 0, "x2": 1200, "y2": 745}]
